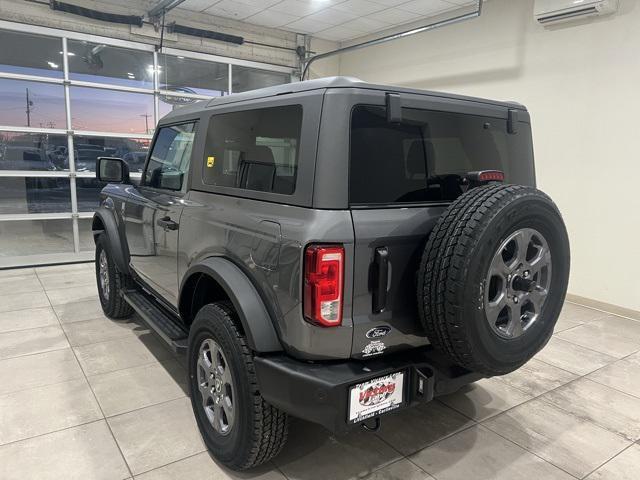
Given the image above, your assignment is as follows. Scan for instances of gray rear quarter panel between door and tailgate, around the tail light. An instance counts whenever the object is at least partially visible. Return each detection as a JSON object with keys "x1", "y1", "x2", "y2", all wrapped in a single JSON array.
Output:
[{"x1": 178, "y1": 191, "x2": 353, "y2": 359}]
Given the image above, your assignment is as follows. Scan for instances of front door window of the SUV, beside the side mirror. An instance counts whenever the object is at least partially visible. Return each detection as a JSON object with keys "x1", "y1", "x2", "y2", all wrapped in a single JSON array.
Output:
[{"x1": 143, "y1": 122, "x2": 196, "y2": 190}]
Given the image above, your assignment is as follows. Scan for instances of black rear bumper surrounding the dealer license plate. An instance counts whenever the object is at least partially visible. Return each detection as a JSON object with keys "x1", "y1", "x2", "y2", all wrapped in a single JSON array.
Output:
[{"x1": 254, "y1": 347, "x2": 483, "y2": 433}]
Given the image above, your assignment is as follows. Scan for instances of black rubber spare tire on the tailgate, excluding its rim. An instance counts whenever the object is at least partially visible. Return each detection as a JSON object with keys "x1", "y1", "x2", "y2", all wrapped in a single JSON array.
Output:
[{"x1": 417, "y1": 185, "x2": 569, "y2": 375}]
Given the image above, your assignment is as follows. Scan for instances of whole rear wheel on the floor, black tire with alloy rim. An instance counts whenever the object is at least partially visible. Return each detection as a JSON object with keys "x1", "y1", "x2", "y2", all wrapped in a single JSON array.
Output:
[{"x1": 188, "y1": 302, "x2": 288, "y2": 470}]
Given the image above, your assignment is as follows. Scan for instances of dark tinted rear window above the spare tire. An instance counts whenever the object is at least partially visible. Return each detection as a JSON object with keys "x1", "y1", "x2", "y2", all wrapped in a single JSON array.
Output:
[{"x1": 349, "y1": 105, "x2": 534, "y2": 205}]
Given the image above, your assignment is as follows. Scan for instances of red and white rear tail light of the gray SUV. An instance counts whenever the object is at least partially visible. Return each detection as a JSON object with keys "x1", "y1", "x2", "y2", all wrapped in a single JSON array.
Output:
[{"x1": 303, "y1": 245, "x2": 344, "y2": 327}]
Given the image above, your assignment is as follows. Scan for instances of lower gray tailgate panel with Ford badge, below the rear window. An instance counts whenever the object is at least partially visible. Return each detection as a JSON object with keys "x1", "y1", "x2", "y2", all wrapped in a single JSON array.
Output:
[{"x1": 351, "y1": 206, "x2": 445, "y2": 358}]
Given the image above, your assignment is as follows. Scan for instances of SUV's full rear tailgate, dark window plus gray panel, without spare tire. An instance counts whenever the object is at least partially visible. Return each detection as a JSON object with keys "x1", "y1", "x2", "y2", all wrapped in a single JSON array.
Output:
[{"x1": 349, "y1": 102, "x2": 535, "y2": 358}]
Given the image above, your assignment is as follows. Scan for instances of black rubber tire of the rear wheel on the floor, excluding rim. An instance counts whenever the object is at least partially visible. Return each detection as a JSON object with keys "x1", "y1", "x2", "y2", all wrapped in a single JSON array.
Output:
[{"x1": 188, "y1": 302, "x2": 289, "y2": 470}]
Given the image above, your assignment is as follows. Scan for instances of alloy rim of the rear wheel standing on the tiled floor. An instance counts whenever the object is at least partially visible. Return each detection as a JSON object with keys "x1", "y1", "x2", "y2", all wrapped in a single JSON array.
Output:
[{"x1": 197, "y1": 338, "x2": 235, "y2": 435}]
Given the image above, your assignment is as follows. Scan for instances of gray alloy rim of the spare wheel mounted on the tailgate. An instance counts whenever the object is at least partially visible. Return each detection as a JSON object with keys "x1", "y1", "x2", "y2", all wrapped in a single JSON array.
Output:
[{"x1": 484, "y1": 228, "x2": 552, "y2": 340}]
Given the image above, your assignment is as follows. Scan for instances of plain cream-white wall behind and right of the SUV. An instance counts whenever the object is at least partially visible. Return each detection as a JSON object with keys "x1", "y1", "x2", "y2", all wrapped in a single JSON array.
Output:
[{"x1": 339, "y1": 0, "x2": 640, "y2": 311}]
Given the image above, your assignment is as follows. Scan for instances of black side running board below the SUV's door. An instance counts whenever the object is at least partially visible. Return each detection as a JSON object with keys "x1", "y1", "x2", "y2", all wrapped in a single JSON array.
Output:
[{"x1": 122, "y1": 290, "x2": 189, "y2": 353}]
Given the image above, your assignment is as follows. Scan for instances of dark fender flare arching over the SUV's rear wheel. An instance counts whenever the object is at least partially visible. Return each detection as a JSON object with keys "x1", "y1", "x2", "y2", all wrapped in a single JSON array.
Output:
[{"x1": 179, "y1": 257, "x2": 282, "y2": 353}]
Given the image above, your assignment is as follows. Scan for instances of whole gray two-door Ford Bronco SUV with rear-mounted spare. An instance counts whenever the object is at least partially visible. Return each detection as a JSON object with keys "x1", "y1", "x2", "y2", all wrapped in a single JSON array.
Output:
[{"x1": 93, "y1": 77, "x2": 569, "y2": 469}]
